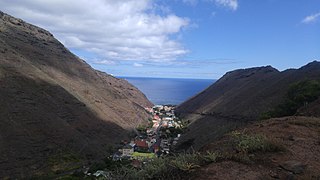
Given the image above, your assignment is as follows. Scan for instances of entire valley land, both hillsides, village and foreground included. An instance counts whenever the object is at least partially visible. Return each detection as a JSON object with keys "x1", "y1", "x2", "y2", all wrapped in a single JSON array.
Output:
[{"x1": 0, "y1": 11, "x2": 320, "y2": 179}]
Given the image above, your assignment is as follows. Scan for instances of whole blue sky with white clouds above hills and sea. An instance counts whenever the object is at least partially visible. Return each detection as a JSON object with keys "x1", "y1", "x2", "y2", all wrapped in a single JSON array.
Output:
[{"x1": 0, "y1": 0, "x2": 320, "y2": 79}]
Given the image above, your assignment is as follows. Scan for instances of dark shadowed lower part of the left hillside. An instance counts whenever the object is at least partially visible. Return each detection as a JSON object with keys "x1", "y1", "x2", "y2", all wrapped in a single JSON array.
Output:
[{"x1": 0, "y1": 70, "x2": 126, "y2": 177}]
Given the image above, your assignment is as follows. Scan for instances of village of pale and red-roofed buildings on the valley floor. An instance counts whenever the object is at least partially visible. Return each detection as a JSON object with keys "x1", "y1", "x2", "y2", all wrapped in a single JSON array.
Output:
[{"x1": 112, "y1": 105, "x2": 184, "y2": 164}]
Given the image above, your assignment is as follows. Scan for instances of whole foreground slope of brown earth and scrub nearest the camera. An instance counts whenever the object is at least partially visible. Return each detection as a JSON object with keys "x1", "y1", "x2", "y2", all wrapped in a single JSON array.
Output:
[{"x1": 29, "y1": 116, "x2": 320, "y2": 180}]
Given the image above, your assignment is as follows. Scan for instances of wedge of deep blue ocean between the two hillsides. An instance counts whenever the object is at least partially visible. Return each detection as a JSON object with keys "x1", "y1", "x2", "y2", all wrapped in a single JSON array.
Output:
[{"x1": 119, "y1": 77, "x2": 215, "y2": 105}]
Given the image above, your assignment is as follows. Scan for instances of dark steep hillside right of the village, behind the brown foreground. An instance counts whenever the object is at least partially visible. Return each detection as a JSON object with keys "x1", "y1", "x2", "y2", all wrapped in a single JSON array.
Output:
[{"x1": 177, "y1": 61, "x2": 320, "y2": 149}]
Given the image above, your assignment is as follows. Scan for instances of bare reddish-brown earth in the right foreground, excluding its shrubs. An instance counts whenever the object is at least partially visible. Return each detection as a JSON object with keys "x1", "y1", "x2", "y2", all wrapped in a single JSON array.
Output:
[{"x1": 189, "y1": 116, "x2": 320, "y2": 179}]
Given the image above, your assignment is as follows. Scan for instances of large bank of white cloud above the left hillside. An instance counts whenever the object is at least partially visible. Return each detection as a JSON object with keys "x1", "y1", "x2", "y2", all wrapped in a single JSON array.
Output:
[{"x1": 0, "y1": 0, "x2": 189, "y2": 64}]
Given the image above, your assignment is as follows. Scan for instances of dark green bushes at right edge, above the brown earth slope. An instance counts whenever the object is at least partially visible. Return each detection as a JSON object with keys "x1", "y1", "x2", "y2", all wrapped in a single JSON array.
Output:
[{"x1": 261, "y1": 80, "x2": 320, "y2": 119}]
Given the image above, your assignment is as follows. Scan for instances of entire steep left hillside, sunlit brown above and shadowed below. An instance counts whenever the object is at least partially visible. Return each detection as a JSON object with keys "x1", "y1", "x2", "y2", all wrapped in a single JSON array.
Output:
[{"x1": 0, "y1": 12, "x2": 152, "y2": 177}]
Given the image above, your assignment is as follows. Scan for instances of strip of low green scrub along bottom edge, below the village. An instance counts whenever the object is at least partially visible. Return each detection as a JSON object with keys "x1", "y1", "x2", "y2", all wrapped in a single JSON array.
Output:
[{"x1": 56, "y1": 152, "x2": 219, "y2": 179}]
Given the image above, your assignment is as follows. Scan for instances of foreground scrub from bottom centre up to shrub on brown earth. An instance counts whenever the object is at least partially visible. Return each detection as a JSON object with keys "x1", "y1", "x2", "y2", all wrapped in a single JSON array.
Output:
[{"x1": 57, "y1": 131, "x2": 284, "y2": 179}]
